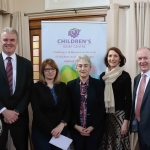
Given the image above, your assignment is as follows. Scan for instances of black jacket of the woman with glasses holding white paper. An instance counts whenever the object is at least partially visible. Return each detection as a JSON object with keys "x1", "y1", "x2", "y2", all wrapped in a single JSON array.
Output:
[{"x1": 31, "y1": 82, "x2": 70, "y2": 135}]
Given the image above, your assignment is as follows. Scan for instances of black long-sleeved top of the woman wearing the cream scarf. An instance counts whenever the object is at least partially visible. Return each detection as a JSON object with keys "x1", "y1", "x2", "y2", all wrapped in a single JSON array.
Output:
[{"x1": 100, "y1": 71, "x2": 132, "y2": 120}]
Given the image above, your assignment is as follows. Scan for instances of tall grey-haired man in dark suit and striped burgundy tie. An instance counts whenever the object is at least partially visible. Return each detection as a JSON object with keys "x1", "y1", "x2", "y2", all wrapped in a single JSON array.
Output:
[{"x1": 0, "y1": 27, "x2": 33, "y2": 150}]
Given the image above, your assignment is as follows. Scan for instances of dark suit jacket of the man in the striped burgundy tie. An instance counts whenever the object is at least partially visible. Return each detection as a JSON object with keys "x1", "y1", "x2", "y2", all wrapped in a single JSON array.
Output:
[{"x1": 0, "y1": 53, "x2": 33, "y2": 124}]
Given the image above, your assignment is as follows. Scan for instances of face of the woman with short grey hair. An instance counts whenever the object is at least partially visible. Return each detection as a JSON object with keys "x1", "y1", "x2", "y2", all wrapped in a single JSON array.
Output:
[{"x1": 76, "y1": 59, "x2": 91, "y2": 78}]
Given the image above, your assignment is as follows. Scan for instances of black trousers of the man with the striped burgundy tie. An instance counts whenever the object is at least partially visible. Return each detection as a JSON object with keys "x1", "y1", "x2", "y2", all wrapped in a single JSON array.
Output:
[{"x1": 0, "y1": 119, "x2": 29, "y2": 150}]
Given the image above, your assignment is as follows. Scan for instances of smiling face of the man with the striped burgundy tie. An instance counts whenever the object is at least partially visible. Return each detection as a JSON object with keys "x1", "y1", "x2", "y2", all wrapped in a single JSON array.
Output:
[{"x1": 0, "y1": 32, "x2": 18, "y2": 56}]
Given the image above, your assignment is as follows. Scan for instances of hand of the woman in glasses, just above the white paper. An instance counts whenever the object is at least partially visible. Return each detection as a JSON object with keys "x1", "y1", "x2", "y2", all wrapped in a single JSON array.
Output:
[{"x1": 51, "y1": 123, "x2": 65, "y2": 138}]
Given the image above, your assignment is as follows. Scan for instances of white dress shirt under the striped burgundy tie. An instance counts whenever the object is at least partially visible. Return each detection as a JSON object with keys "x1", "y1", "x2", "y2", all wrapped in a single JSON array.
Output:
[{"x1": 0, "y1": 51, "x2": 17, "y2": 113}]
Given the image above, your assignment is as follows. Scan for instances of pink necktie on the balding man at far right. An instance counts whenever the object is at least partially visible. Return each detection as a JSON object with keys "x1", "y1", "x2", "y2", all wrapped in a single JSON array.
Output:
[{"x1": 135, "y1": 73, "x2": 146, "y2": 121}]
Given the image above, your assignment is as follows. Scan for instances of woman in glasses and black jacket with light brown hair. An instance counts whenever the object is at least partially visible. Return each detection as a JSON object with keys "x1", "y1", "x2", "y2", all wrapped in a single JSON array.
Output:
[{"x1": 31, "y1": 59, "x2": 70, "y2": 150}]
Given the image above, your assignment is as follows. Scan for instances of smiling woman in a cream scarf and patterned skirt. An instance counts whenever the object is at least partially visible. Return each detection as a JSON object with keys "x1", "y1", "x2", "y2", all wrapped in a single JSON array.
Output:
[{"x1": 100, "y1": 47, "x2": 132, "y2": 150}]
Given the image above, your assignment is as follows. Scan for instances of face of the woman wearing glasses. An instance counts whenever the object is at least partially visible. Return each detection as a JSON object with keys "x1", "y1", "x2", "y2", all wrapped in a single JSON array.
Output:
[{"x1": 44, "y1": 65, "x2": 56, "y2": 80}]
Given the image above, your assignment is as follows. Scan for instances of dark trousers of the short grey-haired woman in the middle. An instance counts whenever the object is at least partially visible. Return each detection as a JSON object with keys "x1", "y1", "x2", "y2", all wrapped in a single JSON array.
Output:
[{"x1": 71, "y1": 130, "x2": 102, "y2": 150}]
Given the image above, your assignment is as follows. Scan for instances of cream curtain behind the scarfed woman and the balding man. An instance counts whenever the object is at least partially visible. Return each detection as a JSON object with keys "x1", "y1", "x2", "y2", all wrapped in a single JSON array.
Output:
[{"x1": 107, "y1": 1, "x2": 150, "y2": 150}]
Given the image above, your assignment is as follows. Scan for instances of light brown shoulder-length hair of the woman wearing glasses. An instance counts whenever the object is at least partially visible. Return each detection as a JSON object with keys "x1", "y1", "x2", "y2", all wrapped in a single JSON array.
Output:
[{"x1": 39, "y1": 58, "x2": 60, "y2": 84}]
